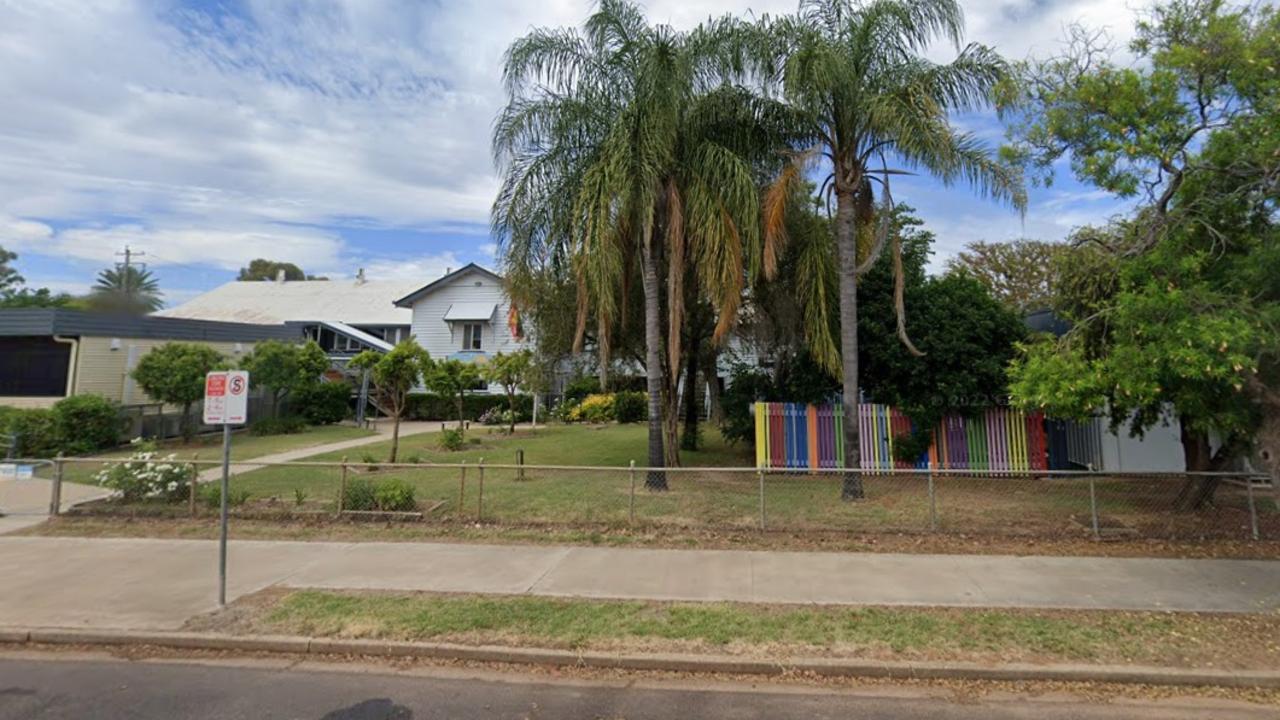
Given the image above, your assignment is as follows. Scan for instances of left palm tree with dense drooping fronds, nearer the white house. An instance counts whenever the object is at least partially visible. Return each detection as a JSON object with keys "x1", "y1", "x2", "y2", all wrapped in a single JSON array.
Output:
[{"x1": 494, "y1": 0, "x2": 788, "y2": 489}]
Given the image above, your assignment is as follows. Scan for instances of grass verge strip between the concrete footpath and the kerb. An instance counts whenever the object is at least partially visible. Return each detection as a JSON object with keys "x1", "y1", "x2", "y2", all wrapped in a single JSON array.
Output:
[{"x1": 188, "y1": 589, "x2": 1280, "y2": 669}]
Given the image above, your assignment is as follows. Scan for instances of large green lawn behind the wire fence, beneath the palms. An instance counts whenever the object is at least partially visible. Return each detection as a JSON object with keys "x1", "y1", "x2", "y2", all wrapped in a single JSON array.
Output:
[{"x1": 220, "y1": 425, "x2": 1280, "y2": 538}]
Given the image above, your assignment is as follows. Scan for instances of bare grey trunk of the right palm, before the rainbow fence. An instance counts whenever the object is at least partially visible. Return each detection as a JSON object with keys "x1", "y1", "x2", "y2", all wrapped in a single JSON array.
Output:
[{"x1": 836, "y1": 185, "x2": 865, "y2": 500}]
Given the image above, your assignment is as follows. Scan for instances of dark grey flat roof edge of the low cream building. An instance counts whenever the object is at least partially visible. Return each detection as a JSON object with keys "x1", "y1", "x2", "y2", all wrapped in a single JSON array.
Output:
[{"x1": 0, "y1": 309, "x2": 302, "y2": 342}]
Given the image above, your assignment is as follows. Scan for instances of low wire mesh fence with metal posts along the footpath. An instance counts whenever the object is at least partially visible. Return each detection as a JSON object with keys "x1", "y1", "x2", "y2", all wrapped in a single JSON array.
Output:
[{"x1": 0, "y1": 459, "x2": 1280, "y2": 539}]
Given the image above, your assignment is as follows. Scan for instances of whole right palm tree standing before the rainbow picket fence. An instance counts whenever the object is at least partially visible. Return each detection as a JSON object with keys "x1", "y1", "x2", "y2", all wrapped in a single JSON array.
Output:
[{"x1": 739, "y1": 0, "x2": 1025, "y2": 491}]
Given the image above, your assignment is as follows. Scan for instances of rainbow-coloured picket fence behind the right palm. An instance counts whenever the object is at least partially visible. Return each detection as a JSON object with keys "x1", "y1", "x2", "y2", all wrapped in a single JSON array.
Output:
[{"x1": 755, "y1": 402, "x2": 1064, "y2": 473}]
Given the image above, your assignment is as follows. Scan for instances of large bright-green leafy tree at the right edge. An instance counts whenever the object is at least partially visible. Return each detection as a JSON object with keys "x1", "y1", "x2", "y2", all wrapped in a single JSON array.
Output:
[{"x1": 1009, "y1": 0, "x2": 1280, "y2": 509}]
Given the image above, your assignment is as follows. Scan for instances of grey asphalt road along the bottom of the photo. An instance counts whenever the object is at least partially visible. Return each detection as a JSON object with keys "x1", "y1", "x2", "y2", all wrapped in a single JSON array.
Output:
[{"x1": 0, "y1": 655, "x2": 1276, "y2": 720}]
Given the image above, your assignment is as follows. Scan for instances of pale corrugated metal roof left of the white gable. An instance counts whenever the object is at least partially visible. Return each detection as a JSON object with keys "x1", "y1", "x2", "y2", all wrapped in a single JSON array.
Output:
[{"x1": 155, "y1": 281, "x2": 421, "y2": 325}]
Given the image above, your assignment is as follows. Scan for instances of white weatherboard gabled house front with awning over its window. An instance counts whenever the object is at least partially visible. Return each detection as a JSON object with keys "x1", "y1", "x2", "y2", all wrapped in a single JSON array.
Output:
[{"x1": 394, "y1": 263, "x2": 531, "y2": 392}]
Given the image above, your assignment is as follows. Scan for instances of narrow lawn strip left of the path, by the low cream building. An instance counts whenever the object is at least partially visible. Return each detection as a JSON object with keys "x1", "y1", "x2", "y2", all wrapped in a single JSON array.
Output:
[{"x1": 52, "y1": 425, "x2": 375, "y2": 483}]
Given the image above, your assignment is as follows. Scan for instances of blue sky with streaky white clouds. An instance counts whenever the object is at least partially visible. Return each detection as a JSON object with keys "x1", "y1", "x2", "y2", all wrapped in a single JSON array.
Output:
[{"x1": 0, "y1": 0, "x2": 1135, "y2": 305}]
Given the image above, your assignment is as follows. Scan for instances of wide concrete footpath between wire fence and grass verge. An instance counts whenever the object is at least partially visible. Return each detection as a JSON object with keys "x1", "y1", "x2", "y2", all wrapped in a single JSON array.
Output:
[{"x1": 0, "y1": 537, "x2": 1280, "y2": 629}]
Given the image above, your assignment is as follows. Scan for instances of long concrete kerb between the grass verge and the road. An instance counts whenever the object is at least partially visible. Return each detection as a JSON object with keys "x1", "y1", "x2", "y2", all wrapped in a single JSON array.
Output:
[{"x1": 0, "y1": 628, "x2": 1280, "y2": 689}]
